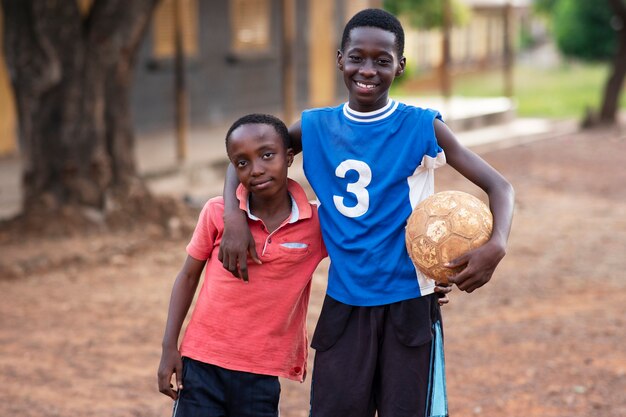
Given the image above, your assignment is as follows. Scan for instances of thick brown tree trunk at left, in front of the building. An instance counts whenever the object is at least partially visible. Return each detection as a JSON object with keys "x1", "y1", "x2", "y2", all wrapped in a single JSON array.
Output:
[{"x1": 2, "y1": 0, "x2": 158, "y2": 213}]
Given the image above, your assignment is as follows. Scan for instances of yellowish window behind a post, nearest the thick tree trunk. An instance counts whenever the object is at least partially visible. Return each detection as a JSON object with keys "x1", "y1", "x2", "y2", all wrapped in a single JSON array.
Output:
[{"x1": 152, "y1": 0, "x2": 198, "y2": 59}]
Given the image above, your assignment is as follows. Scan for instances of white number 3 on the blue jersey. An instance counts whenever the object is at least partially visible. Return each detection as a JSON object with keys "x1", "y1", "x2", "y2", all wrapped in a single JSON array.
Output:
[{"x1": 333, "y1": 159, "x2": 372, "y2": 217}]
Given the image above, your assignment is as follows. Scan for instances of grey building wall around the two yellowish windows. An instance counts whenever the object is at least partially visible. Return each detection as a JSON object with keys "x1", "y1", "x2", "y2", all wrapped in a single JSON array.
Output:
[{"x1": 132, "y1": 0, "x2": 294, "y2": 129}]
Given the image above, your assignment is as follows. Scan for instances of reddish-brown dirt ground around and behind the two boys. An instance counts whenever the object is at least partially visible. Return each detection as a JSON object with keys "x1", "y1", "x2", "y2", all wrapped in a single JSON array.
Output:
[{"x1": 0, "y1": 130, "x2": 626, "y2": 417}]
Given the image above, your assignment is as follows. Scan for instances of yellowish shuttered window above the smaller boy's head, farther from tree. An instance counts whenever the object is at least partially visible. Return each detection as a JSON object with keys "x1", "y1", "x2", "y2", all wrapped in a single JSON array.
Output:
[{"x1": 230, "y1": 0, "x2": 271, "y2": 53}]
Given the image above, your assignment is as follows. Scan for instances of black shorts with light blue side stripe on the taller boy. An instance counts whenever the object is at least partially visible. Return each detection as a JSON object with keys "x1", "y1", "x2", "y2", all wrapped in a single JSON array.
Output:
[{"x1": 311, "y1": 294, "x2": 448, "y2": 417}]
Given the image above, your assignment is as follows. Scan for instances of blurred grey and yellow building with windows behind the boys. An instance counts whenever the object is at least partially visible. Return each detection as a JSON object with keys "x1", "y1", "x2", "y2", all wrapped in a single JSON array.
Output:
[{"x1": 0, "y1": 0, "x2": 529, "y2": 156}]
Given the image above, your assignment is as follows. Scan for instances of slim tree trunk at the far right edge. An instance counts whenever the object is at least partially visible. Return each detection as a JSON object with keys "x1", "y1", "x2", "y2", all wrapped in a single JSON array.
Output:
[{"x1": 599, "y1": 0, "x2": 626, "y2": 124}]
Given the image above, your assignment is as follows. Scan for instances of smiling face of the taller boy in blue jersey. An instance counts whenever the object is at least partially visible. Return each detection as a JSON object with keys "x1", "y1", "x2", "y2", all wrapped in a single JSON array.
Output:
[{"x1": 337, "y1": 26, "x2": 406, "y2": 112}]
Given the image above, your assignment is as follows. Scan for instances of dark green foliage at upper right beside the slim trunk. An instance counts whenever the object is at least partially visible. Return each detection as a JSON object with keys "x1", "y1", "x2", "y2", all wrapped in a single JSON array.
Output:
[{"x1": 554, "y1": 0, "x2": 617, "y2": 61}]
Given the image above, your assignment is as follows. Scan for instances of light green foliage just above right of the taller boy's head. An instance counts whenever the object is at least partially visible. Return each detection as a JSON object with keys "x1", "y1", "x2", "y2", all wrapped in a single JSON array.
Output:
[{"x1": 383, "y1": 0, "x2": 469, "y2": 29}]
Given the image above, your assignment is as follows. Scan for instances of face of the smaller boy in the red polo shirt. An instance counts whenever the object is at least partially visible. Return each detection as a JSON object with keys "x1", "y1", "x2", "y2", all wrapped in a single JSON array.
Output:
[{"x1": 227, "y1": 123, "x2": 293, "y2": 197}]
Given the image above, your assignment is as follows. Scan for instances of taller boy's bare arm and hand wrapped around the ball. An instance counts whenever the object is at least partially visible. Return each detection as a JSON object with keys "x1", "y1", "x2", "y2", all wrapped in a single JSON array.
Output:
[{"x1": 435, "y1": 120, "x2": 515, "y2": 292}]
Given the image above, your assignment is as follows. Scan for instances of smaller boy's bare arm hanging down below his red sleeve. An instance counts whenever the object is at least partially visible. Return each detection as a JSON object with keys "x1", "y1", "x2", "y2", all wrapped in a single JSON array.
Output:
[{"x1": 157, "y1": 256, "x2": 206, "y2": 400}]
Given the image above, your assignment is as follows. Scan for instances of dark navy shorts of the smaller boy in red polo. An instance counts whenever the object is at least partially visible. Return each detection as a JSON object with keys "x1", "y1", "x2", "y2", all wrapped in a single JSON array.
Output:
[{"x1": 173, "y1": 357, "x2": 280, "y2": 417}]
